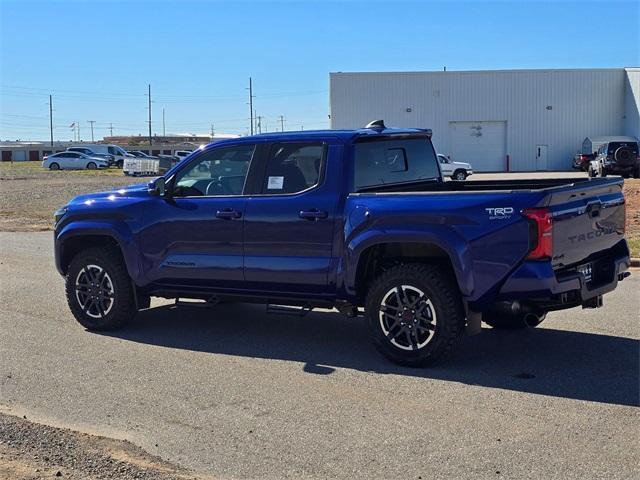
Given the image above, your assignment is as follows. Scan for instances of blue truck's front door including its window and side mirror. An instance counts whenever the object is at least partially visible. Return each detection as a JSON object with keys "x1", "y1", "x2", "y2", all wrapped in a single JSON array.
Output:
[{"x1": 141, "y1": 144, "x2": 255, "y2": 290}]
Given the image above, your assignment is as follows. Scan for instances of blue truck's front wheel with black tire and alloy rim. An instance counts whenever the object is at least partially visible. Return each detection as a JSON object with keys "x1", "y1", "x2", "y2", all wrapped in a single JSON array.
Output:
[{"x1": 66, "y1": 247, "x2": 137, "y2": 331}]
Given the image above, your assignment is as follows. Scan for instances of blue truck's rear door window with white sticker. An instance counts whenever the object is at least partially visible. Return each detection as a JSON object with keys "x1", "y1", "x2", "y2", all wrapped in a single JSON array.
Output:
[{"x1": 262, "y1": 143, "x2": 324, "y2": 195}]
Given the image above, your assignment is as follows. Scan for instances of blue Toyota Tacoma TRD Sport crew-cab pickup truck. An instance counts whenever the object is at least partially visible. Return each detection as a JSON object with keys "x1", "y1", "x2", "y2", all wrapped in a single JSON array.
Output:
[{"x1": 55, "y1": 122, "x2": 630, "y2": 366}]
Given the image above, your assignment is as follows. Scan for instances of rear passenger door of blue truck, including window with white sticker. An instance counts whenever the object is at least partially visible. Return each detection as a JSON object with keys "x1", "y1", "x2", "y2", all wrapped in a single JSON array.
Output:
[{"x1": 244, "y1": 142, "x2": 341, "y2": 296}]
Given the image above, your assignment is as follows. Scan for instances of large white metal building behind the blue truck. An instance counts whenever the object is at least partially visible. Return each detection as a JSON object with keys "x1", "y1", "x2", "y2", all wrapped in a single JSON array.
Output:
[{"x1": 330, "y1": 68, "x2": 640, "y2": 171}]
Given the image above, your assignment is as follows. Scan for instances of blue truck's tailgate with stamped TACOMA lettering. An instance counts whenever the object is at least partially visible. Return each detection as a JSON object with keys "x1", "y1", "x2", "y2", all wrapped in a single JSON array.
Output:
[{"x1": 549, "y1": 178, "x2": 625, "y2": 269}]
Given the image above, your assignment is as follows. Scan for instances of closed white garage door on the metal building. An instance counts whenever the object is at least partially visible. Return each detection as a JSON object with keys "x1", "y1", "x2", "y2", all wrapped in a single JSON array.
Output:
[{"x1": 449, "y1": 122, "x2": 507, "y2": 172}]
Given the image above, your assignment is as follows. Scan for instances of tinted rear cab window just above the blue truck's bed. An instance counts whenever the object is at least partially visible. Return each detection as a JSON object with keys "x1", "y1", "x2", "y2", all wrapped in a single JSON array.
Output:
[{"x1": 355, "y1": 138, "x2": 439, "y2": 190}]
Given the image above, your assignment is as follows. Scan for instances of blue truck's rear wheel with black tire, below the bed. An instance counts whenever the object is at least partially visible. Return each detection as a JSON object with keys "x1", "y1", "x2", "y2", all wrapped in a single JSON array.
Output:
[{"x1": 365, "y1": 263, "x2": 465, "y2": 367}]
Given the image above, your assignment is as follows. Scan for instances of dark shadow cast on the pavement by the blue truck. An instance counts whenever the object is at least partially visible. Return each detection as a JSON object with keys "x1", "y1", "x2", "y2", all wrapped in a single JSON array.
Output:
[{"x1": 100, "y1": 304, "x2": 640, "y2": 405}]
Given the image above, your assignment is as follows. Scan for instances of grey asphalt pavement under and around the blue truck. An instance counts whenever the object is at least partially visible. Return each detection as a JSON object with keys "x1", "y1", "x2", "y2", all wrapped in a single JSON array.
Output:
[{"x1": 0, "y1": 232, "x2": 640, "y2": 479}]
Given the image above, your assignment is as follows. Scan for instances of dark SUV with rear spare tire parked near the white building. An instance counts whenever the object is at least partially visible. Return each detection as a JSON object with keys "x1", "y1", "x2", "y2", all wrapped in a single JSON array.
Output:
[{"x1": 589, "y1": 137, "x2": 640, "y2": 178}]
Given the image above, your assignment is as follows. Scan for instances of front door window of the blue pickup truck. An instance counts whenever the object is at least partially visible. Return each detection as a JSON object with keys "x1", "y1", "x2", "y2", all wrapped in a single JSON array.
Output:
[{"x1": 173, "y1": 145, "x2": 255, "y2": 197}]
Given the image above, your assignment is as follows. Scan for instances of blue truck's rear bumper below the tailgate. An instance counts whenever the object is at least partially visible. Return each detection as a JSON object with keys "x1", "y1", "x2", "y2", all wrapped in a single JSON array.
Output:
[{"x1": 497, "y1": 240, "x2": 631, "y2": 310}]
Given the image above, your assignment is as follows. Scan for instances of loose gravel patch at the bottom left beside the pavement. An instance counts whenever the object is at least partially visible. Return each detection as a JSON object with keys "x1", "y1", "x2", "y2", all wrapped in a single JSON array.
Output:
[{"x1": 0, "y1": 413, "x2": 210, "y2": 480}]
